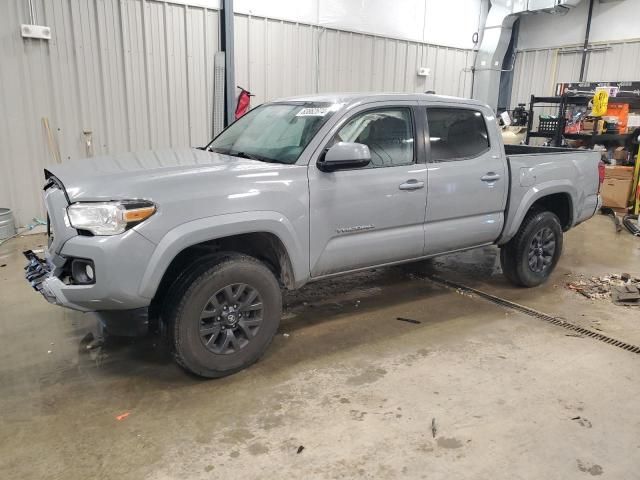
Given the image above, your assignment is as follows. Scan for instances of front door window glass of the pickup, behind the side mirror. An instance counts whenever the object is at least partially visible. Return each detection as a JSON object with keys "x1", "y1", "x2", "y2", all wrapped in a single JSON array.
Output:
[{"x1": 330, "y1": 108, "x2": 414, "y2": 168}]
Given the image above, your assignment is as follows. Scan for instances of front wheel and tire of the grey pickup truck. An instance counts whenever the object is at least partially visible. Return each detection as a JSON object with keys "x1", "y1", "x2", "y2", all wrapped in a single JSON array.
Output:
[{"x1": 163, "y1": 253, "x2": 282, "y2": 378}]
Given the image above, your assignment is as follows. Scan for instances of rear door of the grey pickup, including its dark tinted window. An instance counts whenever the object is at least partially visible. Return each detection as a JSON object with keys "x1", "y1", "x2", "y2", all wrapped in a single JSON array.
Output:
[{"x1": 425, "y1": 104, "x2": 509, "y2": 254}]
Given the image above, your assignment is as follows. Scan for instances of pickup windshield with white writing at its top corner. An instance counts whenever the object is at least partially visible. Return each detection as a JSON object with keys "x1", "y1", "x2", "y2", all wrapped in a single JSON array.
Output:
[{"x1": 206, "y1": 102, "x2": 341, "y2": 164}]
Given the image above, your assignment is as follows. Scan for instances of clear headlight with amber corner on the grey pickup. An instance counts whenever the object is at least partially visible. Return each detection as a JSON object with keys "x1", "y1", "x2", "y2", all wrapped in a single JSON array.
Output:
[{"x1": 67, "y1": 200, "x2": 156, "y2": 235}]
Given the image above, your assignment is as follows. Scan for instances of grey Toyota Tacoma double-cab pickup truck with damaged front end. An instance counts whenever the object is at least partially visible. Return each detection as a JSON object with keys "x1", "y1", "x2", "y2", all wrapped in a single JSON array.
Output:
[{"x1": 25, "y1": 94, "x2": 599, "y2": 377}]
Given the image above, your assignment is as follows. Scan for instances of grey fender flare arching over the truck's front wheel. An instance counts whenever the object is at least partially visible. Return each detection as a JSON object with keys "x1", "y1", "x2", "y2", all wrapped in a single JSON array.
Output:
[{"x1": 138, "y1": 211, "x2": 309, "y2": 299}]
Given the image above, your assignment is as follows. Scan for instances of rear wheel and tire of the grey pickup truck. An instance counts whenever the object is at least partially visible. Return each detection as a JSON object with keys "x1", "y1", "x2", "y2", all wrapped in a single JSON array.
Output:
[{"x1": 500, "y1": 211, "x2": 562, "y2": 287}]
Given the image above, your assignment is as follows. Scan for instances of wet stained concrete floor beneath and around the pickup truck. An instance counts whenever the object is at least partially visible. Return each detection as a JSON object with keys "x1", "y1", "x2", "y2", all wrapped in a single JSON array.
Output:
[{"x1": 0, "y1": 217, "x2": 640, "y2": 480}]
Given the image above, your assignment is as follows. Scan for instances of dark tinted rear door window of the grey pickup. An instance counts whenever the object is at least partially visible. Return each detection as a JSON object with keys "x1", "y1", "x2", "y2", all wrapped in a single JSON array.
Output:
[{"x1": 427, "y1": 108, "x2": 489, "y2": 162}]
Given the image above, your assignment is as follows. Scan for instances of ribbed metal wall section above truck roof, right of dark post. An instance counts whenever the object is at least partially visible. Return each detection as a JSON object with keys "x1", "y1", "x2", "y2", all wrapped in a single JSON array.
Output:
[{"x1": 235, "y1": 15, "x2": 473, "y2": 104}]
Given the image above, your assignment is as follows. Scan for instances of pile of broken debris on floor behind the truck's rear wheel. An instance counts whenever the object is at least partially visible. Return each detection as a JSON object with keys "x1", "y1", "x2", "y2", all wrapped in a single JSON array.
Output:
[{"x1": 566, "y1": 273, "x2": 640, "y2": 305}]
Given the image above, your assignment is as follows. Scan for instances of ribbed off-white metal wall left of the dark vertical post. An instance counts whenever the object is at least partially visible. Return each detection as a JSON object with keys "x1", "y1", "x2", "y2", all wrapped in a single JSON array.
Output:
[{"x1": 0, "y1": 0, "x2": 219, "y2": 224}]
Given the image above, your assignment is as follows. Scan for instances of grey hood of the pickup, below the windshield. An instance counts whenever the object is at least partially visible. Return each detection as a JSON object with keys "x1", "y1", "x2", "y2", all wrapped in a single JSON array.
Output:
[{"x1": 47, "y1": 148, "x2": 294, "y2": 203}]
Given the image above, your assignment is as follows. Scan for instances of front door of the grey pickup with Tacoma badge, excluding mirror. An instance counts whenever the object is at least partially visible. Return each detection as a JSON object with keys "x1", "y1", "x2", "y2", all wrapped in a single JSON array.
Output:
[{"x1": 309, "y1": 102, "x2": 427, "y2": 277}]
